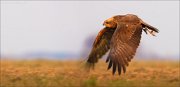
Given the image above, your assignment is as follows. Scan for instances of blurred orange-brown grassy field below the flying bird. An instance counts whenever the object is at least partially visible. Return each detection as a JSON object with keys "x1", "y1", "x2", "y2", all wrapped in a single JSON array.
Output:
[{"x1": 0, "y1": 60, "x2": 180, "y2": 87}]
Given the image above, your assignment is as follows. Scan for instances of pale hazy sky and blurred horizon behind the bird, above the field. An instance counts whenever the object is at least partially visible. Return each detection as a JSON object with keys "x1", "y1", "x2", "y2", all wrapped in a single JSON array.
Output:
[{"x1": 0, "y1": 1, "x2": 179, "y2": 60}]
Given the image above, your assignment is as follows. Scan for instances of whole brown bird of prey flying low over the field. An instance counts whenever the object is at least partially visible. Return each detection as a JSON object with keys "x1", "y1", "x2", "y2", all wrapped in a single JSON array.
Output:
[{"x1": 86, "y1": 14, "x2": 159, "y2": 75}]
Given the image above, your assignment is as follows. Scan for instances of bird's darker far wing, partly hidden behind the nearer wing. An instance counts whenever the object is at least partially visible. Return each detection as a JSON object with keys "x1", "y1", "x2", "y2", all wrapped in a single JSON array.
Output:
[{"x1": 87, "y1": 27, "x2": 115, "y2": 68}]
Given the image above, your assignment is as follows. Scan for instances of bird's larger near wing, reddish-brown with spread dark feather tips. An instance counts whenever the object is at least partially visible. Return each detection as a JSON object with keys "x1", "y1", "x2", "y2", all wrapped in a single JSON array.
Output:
[{"x1": 106, "y1": 24, "x2": 142, "y2": 75}]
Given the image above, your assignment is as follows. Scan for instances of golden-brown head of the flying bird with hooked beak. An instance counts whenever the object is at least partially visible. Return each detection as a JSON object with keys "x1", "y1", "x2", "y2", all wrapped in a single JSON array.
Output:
[{"x1": 103, "y1": 17, "x2": 117, "y2": 28}]
